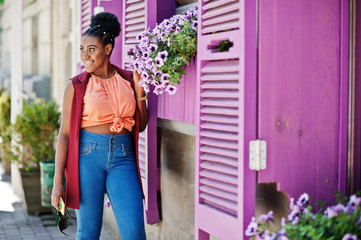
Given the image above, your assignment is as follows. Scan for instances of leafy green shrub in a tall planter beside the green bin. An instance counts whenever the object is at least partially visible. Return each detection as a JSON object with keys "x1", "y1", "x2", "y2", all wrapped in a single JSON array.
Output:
[{"x1": 12, "y1": 100, "x2": 60, "y2": 214}]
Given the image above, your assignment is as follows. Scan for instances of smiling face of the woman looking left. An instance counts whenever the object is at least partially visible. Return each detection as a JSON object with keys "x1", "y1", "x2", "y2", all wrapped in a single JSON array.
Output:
[{"x1": 80, "y1": 36, "x2": 111, "y2": 74}]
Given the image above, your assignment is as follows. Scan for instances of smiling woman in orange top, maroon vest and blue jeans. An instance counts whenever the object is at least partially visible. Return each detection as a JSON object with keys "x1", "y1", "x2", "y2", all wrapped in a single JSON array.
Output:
[{"x1": 52, "y1": 13, "x2": 148, "y2": 240}]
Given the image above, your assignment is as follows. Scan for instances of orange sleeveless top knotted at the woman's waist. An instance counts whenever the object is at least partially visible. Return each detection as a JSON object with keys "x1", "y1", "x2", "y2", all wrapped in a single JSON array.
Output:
[{"x1": 80, "y1": 73, "x2": 136, "y2": 132}]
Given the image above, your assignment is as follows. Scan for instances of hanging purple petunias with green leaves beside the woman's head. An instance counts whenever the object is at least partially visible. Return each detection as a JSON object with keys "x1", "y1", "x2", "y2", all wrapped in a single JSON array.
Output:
[{"x1": 129, "y1": 6, "x2": 198, "y2": 95}]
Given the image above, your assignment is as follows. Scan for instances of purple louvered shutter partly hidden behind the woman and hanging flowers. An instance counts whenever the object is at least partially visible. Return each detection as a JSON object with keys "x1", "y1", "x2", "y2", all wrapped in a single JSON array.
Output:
[{"x1": 122, "y1": 0, "x2": 159, "y2": 223}]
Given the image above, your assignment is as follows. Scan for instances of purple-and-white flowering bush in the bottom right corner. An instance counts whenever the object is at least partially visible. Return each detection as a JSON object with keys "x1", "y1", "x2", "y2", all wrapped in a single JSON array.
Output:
[{"x1": 246, "y1": 192, "x2": 361, "y2": 240}]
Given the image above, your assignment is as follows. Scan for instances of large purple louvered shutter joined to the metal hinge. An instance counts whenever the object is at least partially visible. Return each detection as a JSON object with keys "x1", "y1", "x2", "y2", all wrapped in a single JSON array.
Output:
[{"x1": 195, "y1": 0, "x2": 256, "y2": 239}]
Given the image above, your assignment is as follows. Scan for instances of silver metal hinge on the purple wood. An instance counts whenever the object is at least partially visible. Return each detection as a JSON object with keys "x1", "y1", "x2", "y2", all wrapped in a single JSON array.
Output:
[{"x1": 249, "y1": 140, "x2": 267, "y2": 171}]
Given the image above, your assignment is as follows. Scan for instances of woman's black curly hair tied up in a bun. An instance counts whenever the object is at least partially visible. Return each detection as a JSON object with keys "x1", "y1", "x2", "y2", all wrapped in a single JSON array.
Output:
[{"x1": 83, "y1": 12, "x2": 120, "y2": 54}]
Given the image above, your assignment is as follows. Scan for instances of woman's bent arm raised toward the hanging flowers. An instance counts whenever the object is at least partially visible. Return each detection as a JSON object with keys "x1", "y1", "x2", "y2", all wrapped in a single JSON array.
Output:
[{"x1": 133, "y1": 71, "x2": 149, "y2": 132}]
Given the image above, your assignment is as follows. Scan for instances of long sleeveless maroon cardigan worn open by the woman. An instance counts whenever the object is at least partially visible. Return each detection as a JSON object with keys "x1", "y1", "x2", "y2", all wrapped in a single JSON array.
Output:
[{"x1": 65, "y1": 66, "x2": 144, "y2": 209}]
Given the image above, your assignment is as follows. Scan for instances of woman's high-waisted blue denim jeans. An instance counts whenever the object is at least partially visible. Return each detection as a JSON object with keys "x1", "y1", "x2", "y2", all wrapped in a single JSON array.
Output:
[{"x1": 76, "y1": 130, "x2": 146, "y2": 240}]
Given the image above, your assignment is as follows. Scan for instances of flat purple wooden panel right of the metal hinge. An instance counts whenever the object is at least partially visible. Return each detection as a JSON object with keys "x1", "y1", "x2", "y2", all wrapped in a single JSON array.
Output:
[{"x1": 259, "y1": 0, "x2": 341, "y2": 204}]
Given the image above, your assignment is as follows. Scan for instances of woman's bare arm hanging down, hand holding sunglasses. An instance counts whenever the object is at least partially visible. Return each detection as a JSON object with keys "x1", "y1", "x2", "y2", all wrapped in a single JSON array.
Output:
[{"x1": 51, "y1": 81, "x2": 74, "y2": 211}]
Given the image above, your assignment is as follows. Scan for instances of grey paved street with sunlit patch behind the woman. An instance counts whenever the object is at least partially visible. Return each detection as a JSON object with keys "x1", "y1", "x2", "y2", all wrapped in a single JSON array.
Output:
[{"x1": 0, "y1": 163, "x2": 114, "y2": 240}]
